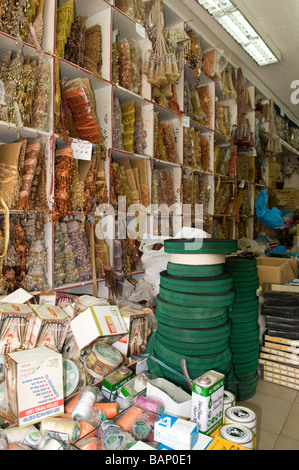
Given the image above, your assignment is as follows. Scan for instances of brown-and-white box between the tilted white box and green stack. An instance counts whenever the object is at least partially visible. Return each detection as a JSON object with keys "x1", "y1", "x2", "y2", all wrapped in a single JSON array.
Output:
[{"x1": 113, "y1": 308, "x2": 148, "y2": 357}]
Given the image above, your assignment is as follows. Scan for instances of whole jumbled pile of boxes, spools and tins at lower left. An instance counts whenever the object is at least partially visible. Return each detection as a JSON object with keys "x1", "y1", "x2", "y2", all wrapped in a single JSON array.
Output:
[{"x1": 0, "y1": 288, "x2": 258, "y2": 451}]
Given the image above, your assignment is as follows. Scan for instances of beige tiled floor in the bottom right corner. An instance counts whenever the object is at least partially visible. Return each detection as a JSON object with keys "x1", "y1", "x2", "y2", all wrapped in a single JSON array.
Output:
[{"x1": 238, "y1": 379, "x2": 299, "y2": 450}]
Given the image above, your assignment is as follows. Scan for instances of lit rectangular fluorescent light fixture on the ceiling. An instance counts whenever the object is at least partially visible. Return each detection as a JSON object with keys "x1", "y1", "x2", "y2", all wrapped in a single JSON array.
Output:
[{"x1": 197, "y1": 0, "x2": 279, "y2": 66}]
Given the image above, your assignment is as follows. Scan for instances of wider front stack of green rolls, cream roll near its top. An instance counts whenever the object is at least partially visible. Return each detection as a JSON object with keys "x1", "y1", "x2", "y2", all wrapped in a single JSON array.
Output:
[{"x1": 147, "y1": 239, "x2": 237, "y2": 390}]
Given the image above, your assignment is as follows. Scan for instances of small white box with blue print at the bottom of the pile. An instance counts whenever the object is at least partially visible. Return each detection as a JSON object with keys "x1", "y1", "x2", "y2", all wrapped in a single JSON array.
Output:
[{"x1": 154, "y1": 413, "x2": 198, "y2": 450}]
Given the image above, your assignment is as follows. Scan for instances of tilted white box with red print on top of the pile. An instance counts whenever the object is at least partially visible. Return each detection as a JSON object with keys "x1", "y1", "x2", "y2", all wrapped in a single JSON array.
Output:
[{"x1": 71, "y1": 305, "x2": 128, "y2": 350}]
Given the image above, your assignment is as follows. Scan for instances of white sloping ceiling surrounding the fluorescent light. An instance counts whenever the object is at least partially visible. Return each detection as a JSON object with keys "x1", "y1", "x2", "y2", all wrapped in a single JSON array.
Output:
[{"x1": 175, "y1": 0, "x2": 299, "y2": 125}]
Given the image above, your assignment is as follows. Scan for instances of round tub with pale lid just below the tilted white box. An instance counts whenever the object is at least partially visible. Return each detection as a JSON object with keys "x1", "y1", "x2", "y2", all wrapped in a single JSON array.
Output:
[{"x1": 86, "y1": 341, "x2": 124, "y2": 376}]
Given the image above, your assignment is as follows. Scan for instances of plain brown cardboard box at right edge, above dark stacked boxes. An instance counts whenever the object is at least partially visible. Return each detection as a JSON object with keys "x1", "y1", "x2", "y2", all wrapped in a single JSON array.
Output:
[{"x1": 257, "y1": 257, "x2": 298, "y2": 287}]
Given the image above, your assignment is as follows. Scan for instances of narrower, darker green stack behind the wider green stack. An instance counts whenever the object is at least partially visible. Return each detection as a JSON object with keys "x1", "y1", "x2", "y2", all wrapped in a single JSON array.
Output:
[{"x1": 225, "y1": 256, "x2": 259, "y2": 401}]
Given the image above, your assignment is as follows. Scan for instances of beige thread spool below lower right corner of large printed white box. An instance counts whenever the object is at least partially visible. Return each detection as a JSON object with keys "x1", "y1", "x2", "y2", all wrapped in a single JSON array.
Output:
[{"x1": 40, "y1": 417, "x2": 81, "y2": 444}]
